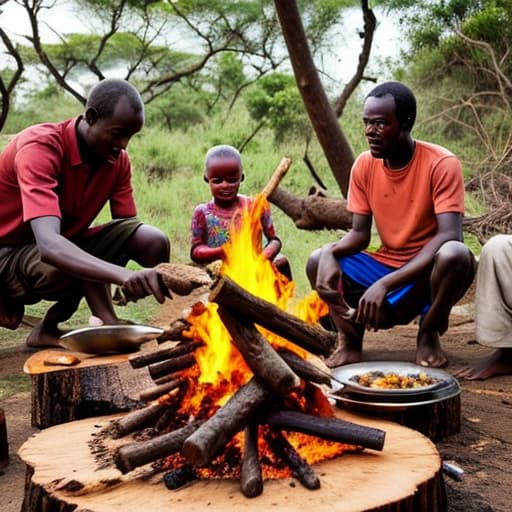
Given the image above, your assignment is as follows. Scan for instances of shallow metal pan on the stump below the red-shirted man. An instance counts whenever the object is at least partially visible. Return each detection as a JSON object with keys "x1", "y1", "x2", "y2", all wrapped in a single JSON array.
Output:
[{"x1": 59, "y1": 324, "x2": 164, "y2": 354}]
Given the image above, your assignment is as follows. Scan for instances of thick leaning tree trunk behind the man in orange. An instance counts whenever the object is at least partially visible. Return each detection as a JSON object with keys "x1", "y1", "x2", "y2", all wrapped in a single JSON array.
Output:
[{"x1": 274, "y1": 0, "x2": 354, "y2": 197}]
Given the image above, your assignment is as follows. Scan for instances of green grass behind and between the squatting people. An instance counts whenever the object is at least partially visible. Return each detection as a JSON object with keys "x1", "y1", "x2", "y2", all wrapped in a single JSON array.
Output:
[{"x1": 0, "y1": 88, "x2": 488, "y2": 330}]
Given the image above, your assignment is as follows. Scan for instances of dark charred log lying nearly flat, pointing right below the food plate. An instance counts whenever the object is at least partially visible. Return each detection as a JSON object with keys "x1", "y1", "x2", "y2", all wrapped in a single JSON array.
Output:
[{"x1": 265, "y1": 410, "x2": 386, "y2": 451}]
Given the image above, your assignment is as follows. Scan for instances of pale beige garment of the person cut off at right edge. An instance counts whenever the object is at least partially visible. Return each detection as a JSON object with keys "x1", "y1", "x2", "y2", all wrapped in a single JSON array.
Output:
[{"x1": 475, "y1": 235, "x2": 512, "y2": 348}]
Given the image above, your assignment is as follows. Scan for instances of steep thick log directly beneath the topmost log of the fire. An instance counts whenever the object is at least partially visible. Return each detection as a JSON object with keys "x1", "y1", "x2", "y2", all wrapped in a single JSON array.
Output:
[{"x1": 218, "y1": 306, "x2": 300, "y2": 396}]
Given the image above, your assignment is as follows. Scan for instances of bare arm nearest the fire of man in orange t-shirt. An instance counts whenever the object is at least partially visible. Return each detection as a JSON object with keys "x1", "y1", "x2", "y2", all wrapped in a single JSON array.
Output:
[{"x1": 315, "y1": 214, "x2": 372, "y2": 303}]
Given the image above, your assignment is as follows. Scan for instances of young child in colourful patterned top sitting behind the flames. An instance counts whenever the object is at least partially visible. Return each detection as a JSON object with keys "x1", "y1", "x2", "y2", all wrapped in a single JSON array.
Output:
[{"x1": 190, "y1": 145, "x2": 292, "y2": 281}]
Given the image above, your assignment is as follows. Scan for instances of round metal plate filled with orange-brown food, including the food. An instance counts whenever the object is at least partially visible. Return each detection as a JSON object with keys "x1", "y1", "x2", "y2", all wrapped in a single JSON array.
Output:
[{"x1": 331, "y1": 361, "x2": 455, "y2": 397}]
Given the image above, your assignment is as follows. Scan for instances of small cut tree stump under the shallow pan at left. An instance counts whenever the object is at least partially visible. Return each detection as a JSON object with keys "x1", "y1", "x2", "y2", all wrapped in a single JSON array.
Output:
[{"x1": 24, "y1": 349, "x2": 154, "y2": 428}]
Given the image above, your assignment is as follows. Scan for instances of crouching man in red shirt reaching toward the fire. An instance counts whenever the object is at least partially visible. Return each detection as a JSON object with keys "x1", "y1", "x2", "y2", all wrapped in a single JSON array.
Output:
[{"x1": 0, "y1": 79, "x2": 170, "y2": 347}]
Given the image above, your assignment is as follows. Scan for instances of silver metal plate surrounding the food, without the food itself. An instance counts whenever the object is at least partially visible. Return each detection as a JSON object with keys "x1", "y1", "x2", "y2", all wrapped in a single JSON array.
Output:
[{"x1": 331, "y1": 361, "x2": 455, "y2": 397}]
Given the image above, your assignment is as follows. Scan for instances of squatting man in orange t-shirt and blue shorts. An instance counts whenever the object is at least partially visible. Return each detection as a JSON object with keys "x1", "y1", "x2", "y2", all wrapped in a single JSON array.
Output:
[{"x1": 306, "y1": 82, "x2": 475, "y2": 367}]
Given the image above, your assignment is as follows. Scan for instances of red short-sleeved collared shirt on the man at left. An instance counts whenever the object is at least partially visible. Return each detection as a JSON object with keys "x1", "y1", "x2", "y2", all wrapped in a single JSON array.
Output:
[{"x1": 0, "y1": 117, "x2": 137, "y2": 246}]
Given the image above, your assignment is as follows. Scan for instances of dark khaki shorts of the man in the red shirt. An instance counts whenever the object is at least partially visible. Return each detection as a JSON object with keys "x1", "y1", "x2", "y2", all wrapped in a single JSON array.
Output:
[{"x1": 0, "y1": 217, "x2": 142, "y2": 309}]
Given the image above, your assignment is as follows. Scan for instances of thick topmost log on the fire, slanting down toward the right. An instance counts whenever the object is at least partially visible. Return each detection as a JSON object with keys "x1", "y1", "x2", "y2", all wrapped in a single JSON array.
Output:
[{"x1": 209, "y1": 276, "x2": 336, "y2": 356}]
